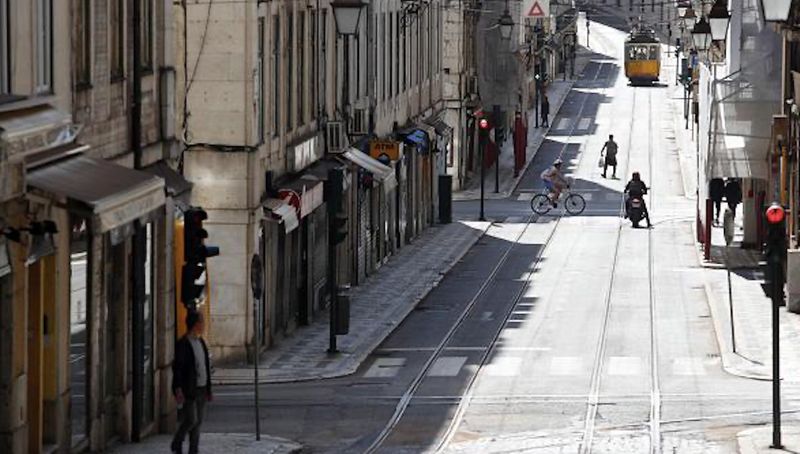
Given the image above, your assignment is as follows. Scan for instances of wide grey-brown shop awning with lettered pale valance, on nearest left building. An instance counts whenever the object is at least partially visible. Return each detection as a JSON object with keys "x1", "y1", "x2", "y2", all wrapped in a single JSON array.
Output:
[{"x1": 27, "y1": 156, "x2": 165, "y2": 233}]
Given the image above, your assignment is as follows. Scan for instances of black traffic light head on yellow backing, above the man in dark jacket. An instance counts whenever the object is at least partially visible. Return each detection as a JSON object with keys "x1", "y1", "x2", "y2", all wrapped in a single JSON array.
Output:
[{"x1": 181, "y1": 208, "x2": 219, "y2": 309}]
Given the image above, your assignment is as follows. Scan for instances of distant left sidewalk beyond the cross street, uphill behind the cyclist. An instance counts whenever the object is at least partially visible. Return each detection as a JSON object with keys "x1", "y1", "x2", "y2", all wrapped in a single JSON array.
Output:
[{"x1": 453, "y1": 47, "x2": 591, "y2": 200}]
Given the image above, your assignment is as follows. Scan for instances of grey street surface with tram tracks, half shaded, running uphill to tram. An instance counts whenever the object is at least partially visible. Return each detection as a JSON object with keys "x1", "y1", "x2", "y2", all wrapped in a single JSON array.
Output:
[{"x1": 205, "y1": 10, "x2": 798, "y2": 453}]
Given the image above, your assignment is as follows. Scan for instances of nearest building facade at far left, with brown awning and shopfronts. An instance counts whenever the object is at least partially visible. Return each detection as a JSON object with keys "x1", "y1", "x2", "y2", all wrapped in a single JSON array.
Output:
[{"x1": 0, "y1": 0, "x2": 183, "y2": 453}]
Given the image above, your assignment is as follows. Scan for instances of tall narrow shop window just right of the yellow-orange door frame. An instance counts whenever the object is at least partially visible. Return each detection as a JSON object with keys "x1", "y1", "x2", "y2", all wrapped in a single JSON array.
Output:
[{"x1": 69, "y1": 216, "x2": 90, "y2": 446}]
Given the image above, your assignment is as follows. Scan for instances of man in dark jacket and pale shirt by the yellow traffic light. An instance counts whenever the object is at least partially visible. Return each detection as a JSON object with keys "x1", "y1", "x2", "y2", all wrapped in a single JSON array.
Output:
[{"x1": 170, "y1": 311, "x2": 212, "y2": 454}]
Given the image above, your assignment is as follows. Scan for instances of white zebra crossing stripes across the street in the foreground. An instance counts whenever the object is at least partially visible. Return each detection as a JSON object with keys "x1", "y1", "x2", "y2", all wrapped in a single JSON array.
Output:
[{"x1": 363, "y1": 354, "x2": 719, "y2": 378}]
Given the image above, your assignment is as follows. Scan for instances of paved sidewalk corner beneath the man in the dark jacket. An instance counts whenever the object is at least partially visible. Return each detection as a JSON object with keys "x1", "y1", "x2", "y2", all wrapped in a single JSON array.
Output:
[{"x1": 107, "y1": 433, "x2": 303, "y2": 454}]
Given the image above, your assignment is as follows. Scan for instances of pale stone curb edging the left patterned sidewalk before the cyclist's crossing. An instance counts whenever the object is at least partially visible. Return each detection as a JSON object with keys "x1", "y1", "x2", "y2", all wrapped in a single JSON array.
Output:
[{"x1": 212, "y1": 221, "x2": 492, "y2": 385}]
